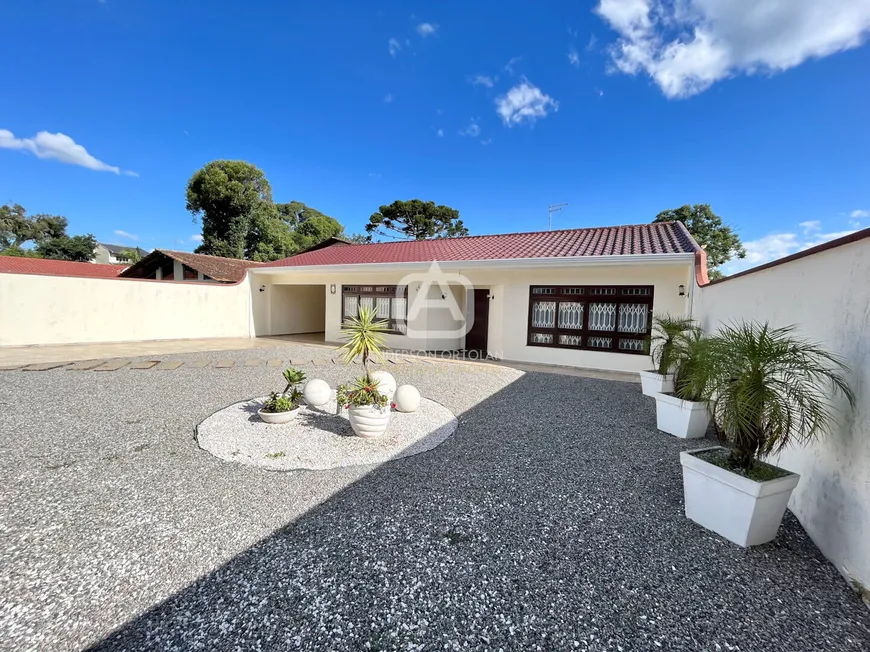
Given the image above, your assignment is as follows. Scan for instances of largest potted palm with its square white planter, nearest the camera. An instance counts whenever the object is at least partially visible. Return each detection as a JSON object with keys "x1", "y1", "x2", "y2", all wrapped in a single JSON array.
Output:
[{"x1": 680, "y1": 322, "x2": 855, "y2": 547}]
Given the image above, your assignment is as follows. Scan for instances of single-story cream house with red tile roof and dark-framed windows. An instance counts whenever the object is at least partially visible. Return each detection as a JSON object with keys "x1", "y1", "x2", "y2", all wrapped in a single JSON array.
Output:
[{"x1": 249, "y1": 222, "x2": 706, "y2": 371}]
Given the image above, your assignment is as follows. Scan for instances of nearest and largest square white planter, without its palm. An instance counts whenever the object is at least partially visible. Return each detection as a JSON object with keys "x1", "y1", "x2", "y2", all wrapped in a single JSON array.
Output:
[{"x1": 680, "y1": 446, "x2": 800, "y2": 548}]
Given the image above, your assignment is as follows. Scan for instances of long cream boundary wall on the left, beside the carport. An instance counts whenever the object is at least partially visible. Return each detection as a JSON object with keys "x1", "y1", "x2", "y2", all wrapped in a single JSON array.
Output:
[{"x1": 0, "y1": 274, "x2": 251, "y2": 346}]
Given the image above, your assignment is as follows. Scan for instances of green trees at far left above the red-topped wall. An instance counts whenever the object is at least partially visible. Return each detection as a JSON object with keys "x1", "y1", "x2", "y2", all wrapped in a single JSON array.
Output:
[{"x1": 0, "y1": 204, "x2": 97, "y2": 263}]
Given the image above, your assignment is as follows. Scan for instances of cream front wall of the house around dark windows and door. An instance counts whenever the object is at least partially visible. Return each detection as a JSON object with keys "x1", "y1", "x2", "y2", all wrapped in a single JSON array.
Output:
[{"x1": 251, "y1": 262, "x2": 694, "y2": 371}]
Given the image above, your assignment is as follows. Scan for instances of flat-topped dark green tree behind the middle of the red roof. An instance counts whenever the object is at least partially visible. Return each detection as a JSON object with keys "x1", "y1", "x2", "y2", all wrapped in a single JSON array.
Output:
[{"x1": 366, "y1": 199, "x2": 468, "y2": 240}]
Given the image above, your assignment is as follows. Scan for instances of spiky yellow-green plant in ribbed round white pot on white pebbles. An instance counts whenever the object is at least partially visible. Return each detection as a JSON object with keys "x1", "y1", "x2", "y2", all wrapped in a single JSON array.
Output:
[{"x1": 336, "y1": 308, "x2": 390, "y2": 437}]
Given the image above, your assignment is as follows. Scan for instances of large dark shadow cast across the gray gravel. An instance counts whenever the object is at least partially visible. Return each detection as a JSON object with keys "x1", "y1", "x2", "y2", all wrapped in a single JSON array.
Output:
[{"x1": 83, "y1": 373, "x2": 870, "y2": 652}]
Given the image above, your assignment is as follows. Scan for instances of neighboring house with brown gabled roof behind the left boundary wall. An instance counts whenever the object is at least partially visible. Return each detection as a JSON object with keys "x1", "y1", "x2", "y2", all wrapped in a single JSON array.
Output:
[{"x1": 121, "y1": 249, "x2": 265, "y2": 283}]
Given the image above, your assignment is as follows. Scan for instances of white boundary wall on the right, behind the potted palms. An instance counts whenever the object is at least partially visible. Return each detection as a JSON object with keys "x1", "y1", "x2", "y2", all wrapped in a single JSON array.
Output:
[{"x1": 695, "y1": 238, "x2": 870, "y2": 586}]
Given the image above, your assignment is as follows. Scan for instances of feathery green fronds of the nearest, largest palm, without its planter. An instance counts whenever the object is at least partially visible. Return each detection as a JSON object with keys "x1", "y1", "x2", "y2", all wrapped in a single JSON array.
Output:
[{"x1": 683, "y1": 322, "x2": 855, "y2": 471}]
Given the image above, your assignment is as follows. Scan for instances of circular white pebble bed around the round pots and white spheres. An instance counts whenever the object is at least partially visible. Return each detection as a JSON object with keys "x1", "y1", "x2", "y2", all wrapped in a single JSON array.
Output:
[{"x1": 196, "y1": 392, "x2": 457, "y2": 471}]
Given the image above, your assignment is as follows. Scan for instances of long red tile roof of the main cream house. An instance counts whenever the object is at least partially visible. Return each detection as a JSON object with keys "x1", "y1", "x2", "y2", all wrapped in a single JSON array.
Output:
[{"x1": 266, "y1": 222, "x2": 700, "y2": 267}]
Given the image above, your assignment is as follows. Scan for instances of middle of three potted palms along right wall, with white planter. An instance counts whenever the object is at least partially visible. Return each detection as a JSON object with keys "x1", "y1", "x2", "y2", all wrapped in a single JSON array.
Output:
[{"x1": 655, "y1": 326, "x2": 710, "y2": 439}]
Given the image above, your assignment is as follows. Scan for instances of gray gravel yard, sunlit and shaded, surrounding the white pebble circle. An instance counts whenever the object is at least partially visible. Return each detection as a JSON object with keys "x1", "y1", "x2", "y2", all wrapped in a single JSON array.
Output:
[{"x1": 0, "y1": 347, "x2": 870, "y2": 652}]
